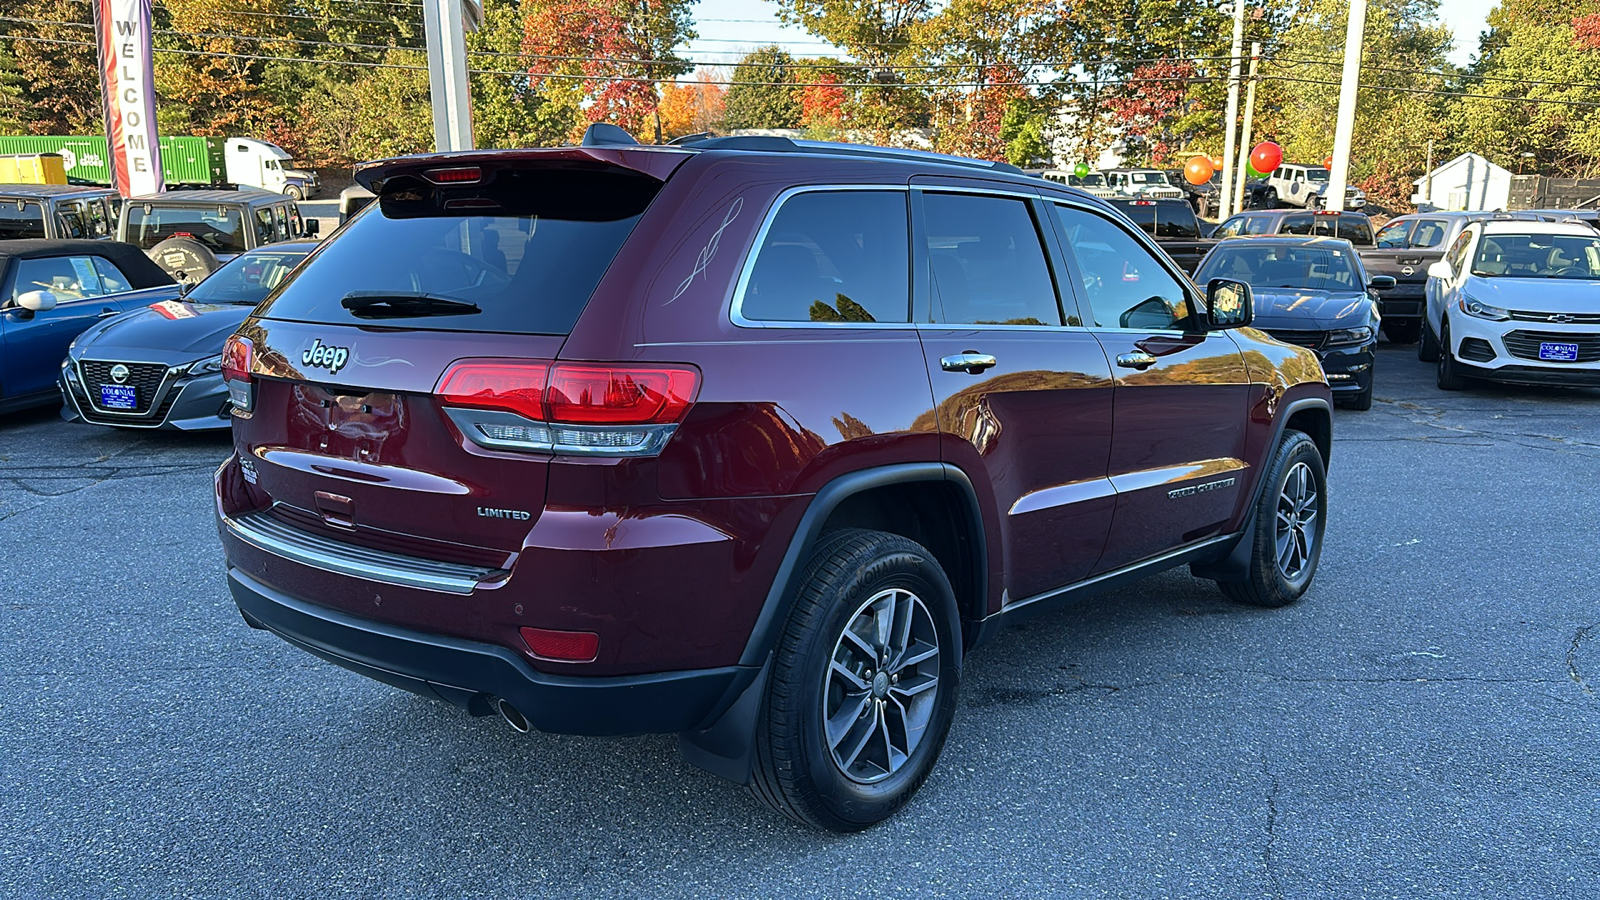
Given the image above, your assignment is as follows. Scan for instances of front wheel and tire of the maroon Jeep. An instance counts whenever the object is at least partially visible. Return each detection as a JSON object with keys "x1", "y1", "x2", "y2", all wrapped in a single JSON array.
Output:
[{"x1": 1216, "y1": 431, "x2": 1328, "y2": 607}]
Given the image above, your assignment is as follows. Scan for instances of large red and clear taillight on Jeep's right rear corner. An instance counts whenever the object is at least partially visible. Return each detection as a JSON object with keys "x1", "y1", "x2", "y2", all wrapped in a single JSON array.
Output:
[{"x1": 435, "y1": 359, "x2": 699, "y2": 456}]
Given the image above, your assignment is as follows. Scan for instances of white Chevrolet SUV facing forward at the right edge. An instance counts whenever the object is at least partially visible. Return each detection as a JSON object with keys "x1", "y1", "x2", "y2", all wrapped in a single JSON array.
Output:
[{"x1": 1416, "y1": 221, "x2": 1600, "y2": 391}]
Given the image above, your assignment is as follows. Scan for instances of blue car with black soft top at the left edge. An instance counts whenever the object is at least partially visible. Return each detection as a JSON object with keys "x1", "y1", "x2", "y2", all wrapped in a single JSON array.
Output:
[{"x1": 0, "y1": 240, "x2": 178, "y2": 413}]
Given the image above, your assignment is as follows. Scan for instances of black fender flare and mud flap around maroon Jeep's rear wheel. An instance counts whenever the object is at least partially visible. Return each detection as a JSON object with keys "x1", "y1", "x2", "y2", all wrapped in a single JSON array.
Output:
[{"x1": 678, "y1": 463, "x2": 989, "y2": 785}]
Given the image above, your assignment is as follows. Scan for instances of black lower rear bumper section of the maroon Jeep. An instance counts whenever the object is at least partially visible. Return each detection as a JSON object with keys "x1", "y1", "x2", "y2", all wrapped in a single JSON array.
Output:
[{"x1": 227, "y1": 569, "x2": 760, "y2": 735}]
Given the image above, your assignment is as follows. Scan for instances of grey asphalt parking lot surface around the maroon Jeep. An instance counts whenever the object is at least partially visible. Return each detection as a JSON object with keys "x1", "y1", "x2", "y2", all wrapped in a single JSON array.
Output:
[{"x1": 0, "y1": 344, "x2": 1600, "y2": 898}]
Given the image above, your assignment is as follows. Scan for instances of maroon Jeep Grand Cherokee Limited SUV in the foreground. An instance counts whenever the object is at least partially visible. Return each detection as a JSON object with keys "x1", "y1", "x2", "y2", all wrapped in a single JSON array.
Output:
[{"x1": 216, "y1": 127, "x2": 1331, "y2": 831}]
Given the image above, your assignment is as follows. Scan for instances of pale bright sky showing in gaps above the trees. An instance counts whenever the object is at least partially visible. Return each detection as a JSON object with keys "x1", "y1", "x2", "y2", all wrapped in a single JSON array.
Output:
[{"x1": 690, "y1": 0, "x2": 1498, "y2": 66}]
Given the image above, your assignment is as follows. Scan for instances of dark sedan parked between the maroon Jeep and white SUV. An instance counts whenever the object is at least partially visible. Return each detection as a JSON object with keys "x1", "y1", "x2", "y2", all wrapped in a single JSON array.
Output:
[{"x1": 1195, "y1": 237, "x2": 1394, "y2": 410}]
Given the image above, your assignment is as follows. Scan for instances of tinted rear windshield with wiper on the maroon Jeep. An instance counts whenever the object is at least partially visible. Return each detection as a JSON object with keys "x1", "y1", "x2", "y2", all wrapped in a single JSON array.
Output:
[{"x1": 259, "y1": 168, "x2": 661, "y2": 335}]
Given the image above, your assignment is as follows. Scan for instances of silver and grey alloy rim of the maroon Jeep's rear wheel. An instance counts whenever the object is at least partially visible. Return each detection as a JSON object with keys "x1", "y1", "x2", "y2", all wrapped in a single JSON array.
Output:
[{"x1": 822, "y1": 588, "x2": 939, "y2": 785}]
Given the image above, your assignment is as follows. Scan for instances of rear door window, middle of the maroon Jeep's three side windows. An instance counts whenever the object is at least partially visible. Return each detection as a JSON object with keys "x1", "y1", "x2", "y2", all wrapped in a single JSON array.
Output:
[{"x1": 923, "y1": 194, "x2": 1061, "y2": 325}]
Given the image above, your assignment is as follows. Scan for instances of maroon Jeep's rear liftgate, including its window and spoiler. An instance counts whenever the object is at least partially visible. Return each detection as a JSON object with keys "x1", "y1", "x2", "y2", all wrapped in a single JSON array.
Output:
[{"x1": 229, "y1": 151, "x2": 670, "y2": 567}]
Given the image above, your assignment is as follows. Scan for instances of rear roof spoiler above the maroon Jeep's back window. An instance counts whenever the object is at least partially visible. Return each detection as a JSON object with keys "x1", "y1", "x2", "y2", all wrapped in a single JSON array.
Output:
[{"x1": 355, "y1": 146, "x2": 694, "y2": 194}]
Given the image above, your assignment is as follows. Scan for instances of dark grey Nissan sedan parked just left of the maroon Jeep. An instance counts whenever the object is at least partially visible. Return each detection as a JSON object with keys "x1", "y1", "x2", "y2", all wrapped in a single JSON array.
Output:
[{"x1": 59, "y1": 240, "x2": 317, "y2": 431}]
